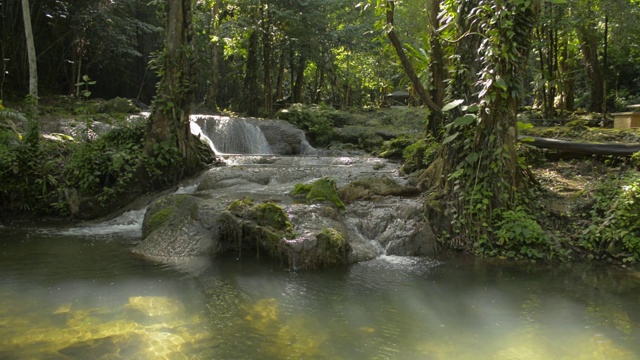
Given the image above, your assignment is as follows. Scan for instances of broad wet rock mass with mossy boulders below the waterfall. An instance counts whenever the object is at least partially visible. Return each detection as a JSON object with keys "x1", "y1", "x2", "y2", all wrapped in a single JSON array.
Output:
[{"x1": 134, "y1": 156, "x2": 435, "y2": 268}]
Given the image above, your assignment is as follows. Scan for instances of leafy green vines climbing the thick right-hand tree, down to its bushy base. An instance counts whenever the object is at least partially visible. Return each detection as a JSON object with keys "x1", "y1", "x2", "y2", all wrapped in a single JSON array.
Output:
[{"x1": 430, "y1": 0, "x2": 555, "y2": 259}]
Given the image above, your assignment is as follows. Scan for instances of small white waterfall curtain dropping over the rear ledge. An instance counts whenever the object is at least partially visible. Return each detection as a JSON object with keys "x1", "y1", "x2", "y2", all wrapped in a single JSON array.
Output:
[{"x1": 198, "y1": 116, "x2": 272, "y2": 155}]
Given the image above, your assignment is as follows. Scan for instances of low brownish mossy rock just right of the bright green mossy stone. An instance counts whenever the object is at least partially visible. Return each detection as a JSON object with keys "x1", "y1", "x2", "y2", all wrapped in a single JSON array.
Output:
[{"x1": 338, "y1": 177, "x2": 420, "y2": 203}]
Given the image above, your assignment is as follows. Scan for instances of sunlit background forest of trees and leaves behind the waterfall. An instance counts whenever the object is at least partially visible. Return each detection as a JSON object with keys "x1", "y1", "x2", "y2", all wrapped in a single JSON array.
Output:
[{"x1": 0, "y1": 0, "x2": 640, "y2": 115}]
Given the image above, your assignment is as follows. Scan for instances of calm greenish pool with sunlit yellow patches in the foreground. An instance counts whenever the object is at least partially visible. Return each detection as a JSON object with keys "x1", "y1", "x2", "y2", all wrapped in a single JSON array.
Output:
[{"x1": 0, "y1": 228, "x2": 640, "y2": 359}]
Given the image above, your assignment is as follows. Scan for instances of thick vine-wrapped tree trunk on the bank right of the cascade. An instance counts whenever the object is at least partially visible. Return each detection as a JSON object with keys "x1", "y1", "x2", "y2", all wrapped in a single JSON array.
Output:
[{"x1": 420, "y1": 0, "x2": 540, "y2": 251}]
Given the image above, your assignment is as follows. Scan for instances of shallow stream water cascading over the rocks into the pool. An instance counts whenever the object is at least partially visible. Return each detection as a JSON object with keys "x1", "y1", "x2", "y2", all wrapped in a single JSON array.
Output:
[{"x1": 50, "y1": 115, "x2": 428, "y2": 261}]
